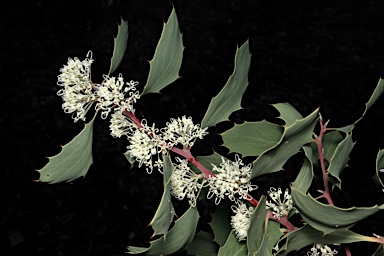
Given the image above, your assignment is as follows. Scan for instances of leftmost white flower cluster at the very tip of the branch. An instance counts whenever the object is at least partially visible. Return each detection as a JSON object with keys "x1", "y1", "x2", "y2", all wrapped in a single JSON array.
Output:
[{"x1": 57, "y1": 51, "x2": 96, "y2": 122}]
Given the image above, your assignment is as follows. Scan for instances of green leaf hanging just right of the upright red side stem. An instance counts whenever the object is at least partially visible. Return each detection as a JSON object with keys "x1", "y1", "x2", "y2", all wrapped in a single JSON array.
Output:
[{"x1": 327, "y1": 132, "x2": 355, "y2": 189}]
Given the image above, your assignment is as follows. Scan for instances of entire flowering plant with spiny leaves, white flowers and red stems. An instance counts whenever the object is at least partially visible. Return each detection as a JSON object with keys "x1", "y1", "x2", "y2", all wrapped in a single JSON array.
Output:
[{"x1": 39, "y1": 7, "x2": 384, "y2": 256}]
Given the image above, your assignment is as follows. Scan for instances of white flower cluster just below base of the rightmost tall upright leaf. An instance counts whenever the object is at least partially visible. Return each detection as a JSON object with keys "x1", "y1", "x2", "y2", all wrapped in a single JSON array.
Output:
[{"x1": 163, "y1": 116, "x2": 208, "y2": 148}]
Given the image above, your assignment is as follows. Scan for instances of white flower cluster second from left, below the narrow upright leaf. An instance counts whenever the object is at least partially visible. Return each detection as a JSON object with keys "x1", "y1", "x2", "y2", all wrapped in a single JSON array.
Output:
[{"x1": 96, "y1": 74, "x2": 140, "y2": 119}]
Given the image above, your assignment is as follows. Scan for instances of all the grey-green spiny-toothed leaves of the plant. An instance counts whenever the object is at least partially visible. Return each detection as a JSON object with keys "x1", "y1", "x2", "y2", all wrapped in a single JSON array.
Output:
[{"x1": 39, "y1": 6, "x2": 384, "y2": 256}]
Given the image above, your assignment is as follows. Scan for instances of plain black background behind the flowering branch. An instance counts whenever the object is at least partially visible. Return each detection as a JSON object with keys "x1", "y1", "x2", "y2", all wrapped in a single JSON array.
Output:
[{"x1": 0, "y1": 0, "x2": 384, "y2": 256}]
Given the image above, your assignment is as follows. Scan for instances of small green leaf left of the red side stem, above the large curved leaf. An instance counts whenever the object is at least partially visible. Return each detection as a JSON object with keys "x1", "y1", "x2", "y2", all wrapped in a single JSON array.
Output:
[{"x1": 292, "y1": 146, "x2": 313, "y2": 193}]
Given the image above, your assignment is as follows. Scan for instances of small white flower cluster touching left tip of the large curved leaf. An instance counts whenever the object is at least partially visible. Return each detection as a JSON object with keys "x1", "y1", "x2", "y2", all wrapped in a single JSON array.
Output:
[{"x1": 266, "y1": 187, "x2": 293, "y2": 219}]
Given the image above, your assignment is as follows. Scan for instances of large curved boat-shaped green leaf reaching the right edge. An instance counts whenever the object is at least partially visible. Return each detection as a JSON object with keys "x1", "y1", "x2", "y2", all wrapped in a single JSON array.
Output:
[{"x1": 291, "y1": 187, "x2": 384, "y2": 234}]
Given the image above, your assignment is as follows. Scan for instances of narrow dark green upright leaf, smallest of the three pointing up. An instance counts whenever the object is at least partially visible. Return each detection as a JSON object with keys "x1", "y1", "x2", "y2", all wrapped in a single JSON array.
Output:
[{"x1": 108, "y1": 20, "x2": 128, "y2": 75}]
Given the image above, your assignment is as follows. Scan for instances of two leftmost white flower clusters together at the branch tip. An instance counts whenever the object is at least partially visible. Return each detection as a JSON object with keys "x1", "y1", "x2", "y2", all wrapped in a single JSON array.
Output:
[{"x1": 57, "y1": 51, "x2": 140, "y2": 122}]
